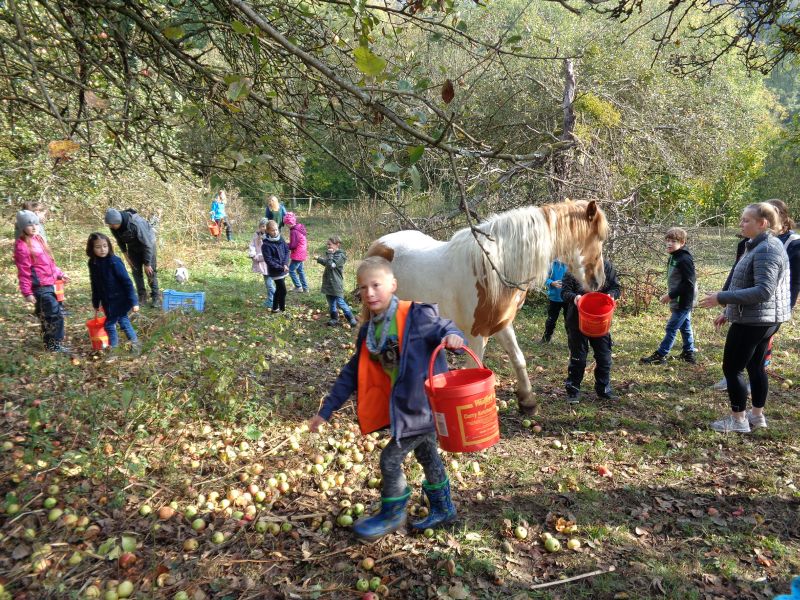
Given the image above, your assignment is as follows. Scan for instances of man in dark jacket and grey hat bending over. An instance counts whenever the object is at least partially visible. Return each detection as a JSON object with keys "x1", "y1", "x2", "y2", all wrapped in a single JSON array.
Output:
[{"x1": 105, "y1": 208, "x2": 160, "y2": 308}]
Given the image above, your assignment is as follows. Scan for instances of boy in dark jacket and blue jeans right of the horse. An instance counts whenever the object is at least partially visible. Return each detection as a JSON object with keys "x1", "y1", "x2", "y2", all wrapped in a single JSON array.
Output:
[{"x1": 639, "y1": 227, "x2": 697, "y2": 365}]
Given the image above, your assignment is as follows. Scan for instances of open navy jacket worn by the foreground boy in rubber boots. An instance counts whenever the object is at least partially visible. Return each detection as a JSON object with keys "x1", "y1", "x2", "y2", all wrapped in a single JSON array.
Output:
[{"x1": 319, "y1": 302, "x2": 464, "y2": 440}]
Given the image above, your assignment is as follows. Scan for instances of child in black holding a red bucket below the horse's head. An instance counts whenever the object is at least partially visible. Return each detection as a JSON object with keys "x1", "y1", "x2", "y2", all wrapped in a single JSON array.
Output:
[{"x1": 561, "y1": 260, "x2": 620, "y2": 404}]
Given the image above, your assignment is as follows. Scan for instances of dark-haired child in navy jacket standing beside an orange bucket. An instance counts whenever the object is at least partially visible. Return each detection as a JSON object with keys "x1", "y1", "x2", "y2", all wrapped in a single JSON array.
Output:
[{"x1": 86, "y1": 233, "x2": 140, "y2": 353}]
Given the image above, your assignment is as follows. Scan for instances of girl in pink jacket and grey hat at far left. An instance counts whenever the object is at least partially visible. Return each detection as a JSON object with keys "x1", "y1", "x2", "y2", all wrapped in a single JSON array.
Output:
[{"x1": 14, "y1": 210, "x2": 69, "y2": 352}]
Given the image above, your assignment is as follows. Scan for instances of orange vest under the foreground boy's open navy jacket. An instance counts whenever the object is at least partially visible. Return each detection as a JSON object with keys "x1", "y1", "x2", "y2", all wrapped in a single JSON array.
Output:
[{"x1": 357, "y1": 300, "x2": 411, "y2": 435}]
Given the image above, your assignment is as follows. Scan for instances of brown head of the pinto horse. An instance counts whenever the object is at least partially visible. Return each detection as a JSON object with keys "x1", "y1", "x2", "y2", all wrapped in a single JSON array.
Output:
[{"x1": 557, "y1": 200, "x2": 608, "y2": 291}]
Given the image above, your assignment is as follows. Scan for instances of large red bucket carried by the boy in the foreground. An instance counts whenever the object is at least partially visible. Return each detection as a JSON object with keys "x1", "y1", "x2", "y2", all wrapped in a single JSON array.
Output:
[{"x1": 425, "y1": 344, "x2": 500, "y2": 452}]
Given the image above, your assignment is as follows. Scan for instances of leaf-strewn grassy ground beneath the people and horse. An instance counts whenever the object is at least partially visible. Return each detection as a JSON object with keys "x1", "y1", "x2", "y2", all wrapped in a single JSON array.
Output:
[{"x1": 0, "y1": 215, "x2": 800, "y2": 599}]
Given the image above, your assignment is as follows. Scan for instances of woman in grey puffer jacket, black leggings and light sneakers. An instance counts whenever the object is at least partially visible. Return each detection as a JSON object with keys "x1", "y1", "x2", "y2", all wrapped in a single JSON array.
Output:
[{"x1": 700, "y1": 202, "x2": 790, "y2": 433}]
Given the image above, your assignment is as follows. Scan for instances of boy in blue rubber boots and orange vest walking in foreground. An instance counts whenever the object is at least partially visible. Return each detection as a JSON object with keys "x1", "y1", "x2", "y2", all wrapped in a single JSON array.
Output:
[{"x1": 309, "y1": 256, "x2": 464, "y2": 542}]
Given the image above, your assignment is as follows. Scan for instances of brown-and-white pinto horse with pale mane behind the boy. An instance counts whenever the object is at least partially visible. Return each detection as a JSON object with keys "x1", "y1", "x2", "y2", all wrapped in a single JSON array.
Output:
[{"x1": 367, "y1": 200, "x2": 608, "y2": 413}]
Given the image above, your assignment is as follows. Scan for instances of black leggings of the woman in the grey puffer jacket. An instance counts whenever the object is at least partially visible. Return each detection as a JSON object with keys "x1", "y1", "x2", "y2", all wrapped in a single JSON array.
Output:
[{"x1": 722, "y1": 323, "x2": 780, "y2": 412}]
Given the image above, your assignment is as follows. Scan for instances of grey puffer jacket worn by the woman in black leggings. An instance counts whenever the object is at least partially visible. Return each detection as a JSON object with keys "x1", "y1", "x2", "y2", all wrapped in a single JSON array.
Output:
[{"x1": 717, "y1": 233, "x2": 791, "y2": 325}]
